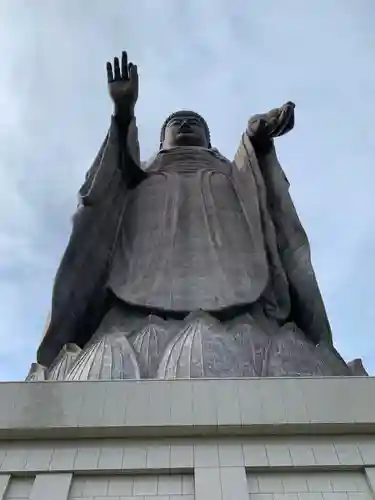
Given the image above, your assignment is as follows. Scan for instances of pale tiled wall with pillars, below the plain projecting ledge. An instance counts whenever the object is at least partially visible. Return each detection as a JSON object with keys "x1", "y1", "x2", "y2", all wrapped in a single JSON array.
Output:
[{"x1": 0, "y1": 435, "x2": 375, "y2": 500}]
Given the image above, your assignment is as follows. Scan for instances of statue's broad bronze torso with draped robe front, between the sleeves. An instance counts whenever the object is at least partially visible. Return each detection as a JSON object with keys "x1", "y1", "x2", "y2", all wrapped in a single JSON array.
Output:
[{"x1": 109, "y1": 148, "x2": 267, "y2": 311}]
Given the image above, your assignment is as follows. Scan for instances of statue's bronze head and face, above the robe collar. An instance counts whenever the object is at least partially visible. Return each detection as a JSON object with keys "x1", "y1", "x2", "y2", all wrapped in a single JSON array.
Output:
[{"x1": 163, "y1": 114, "x2": 209, "y2": 149}]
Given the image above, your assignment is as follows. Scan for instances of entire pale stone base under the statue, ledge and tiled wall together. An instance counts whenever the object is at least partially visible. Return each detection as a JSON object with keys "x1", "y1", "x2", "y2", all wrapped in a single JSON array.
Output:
[{"x1": 0, "y1": 377, "x2": 375, "y2": 500}]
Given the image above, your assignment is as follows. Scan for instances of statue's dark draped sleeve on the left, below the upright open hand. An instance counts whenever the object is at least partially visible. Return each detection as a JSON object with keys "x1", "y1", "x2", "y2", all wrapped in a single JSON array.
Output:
[{"x1": 37, "y1": 117, "x2": 144, "y2": 366}]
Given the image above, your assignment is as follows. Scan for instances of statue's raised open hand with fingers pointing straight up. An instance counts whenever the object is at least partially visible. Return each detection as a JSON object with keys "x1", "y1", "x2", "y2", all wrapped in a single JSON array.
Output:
[{"x1": 107, "y1": 51, "x2": 138, "y2": 109}]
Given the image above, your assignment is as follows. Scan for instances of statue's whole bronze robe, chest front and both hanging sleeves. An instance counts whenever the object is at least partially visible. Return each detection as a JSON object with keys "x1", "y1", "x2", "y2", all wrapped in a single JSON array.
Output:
[{"x1": 38, "y1": 114, "x2": 331, "y2": 366}]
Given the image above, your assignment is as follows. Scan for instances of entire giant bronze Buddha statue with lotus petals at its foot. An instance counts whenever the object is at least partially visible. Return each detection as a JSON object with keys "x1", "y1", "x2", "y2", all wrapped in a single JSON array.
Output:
[{"x1": 28, "y1": 53, "x2": 358, "y2": 380}]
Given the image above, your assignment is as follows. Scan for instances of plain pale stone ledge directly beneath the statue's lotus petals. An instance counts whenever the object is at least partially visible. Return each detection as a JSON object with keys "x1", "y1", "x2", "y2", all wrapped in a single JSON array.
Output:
[{"x1": 0, "y1": 377, "x2": 375, "y2": 439}]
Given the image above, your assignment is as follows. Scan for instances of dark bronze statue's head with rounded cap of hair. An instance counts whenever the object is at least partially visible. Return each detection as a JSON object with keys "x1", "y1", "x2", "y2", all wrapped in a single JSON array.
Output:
[{"x1": 160, "y1": 111, "x2": 211, "y2": 149}]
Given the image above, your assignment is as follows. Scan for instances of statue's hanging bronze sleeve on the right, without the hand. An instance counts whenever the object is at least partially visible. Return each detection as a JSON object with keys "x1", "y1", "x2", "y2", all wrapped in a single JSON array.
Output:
[{"x1": 234, "y1": 133, "x2": 332, "y2": 345}]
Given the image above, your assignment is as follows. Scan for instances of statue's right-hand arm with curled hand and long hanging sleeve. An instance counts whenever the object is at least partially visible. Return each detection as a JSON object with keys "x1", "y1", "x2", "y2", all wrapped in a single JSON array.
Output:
[{"x1": 234, "y1": 102, "x2": 332, "y2": 344}]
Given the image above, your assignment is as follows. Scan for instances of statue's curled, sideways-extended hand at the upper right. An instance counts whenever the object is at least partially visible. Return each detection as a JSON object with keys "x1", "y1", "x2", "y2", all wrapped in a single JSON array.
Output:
[{"x1": 247, "y1": 102, "x2": 295, "y2": 150}]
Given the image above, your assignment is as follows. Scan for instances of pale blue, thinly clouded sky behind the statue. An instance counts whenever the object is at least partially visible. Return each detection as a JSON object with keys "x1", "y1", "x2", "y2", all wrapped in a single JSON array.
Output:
[{"x1": 0, "y1": 0, "x2": 375, "y2": 380}]
